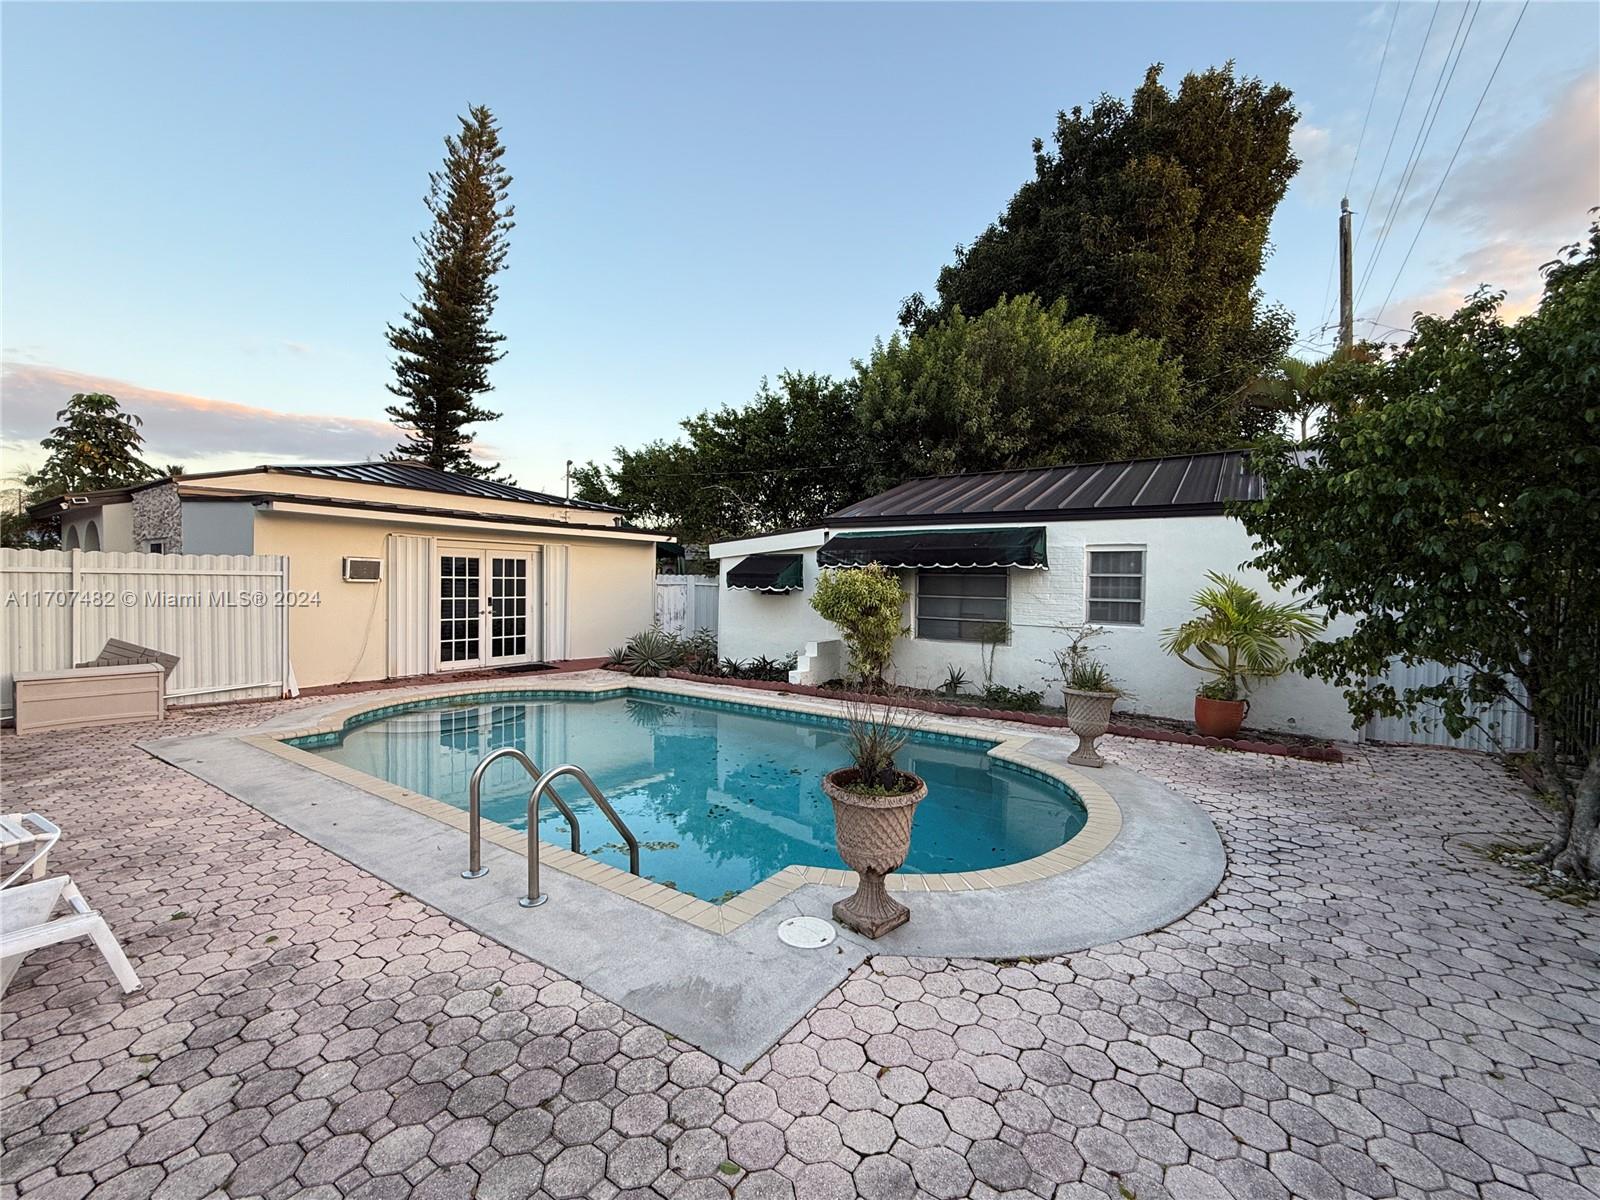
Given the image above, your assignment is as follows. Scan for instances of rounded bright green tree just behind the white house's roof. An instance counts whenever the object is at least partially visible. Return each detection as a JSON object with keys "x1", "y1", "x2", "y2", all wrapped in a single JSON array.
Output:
[{"x1": 858, "y1": 296, "x2": 1184, "y2": 488}]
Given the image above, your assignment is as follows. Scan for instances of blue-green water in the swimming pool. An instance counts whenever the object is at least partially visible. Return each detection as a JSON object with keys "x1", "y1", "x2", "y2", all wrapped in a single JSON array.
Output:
[{"x1": 291, "y1": 690, "x2": 1085, "y2": 902}]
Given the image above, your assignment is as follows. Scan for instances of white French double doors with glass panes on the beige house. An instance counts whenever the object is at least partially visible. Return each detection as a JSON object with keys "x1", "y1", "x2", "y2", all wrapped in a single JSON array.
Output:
[{"x1": 438, "y1": 549, "x2": 539, "y2": 670}]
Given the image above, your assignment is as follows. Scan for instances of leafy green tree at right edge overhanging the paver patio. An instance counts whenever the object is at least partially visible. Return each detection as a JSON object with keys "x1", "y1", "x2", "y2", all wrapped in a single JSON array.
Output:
[{"x1": 1238, "y1": 226, "x2": 1600, "y2": 878}]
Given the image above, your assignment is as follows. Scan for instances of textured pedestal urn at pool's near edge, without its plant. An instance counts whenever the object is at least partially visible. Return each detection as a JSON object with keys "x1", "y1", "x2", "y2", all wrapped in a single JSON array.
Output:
[{"x1": 822, "y1": 766, "x2": 928, "y2": 938}]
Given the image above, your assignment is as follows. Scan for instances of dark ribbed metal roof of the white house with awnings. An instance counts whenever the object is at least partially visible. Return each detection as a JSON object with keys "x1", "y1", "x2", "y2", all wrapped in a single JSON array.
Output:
[{"x1": 827, "y1": 450, "x2": 1261, "y2": 525}]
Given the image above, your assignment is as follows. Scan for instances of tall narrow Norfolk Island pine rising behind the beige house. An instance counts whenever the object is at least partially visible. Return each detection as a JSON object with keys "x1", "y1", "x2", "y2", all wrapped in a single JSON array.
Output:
[{"x1": 389, "y1": 104, "x2": 515, "y2": 477}]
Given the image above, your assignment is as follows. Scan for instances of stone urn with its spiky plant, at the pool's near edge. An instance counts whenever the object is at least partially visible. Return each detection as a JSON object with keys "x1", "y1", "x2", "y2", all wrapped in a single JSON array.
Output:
[{"x1": 822, "y1": 701, "x2": 928, "y2": 938}]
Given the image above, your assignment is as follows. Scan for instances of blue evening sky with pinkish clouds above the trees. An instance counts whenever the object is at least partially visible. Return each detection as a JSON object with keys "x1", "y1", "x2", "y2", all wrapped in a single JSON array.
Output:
[{"x1": 0, "y1": 0, "x2": 1600, "y2": 493}]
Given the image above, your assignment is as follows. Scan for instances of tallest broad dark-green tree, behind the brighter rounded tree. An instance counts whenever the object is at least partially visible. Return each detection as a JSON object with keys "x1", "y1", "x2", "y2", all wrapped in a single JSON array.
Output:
[{"x1": 901, "y1": 62, "x2": 1299, "y2": 448}]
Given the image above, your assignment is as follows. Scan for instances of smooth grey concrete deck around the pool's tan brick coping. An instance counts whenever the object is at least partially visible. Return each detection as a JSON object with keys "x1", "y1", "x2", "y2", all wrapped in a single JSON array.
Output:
[{"x1": 150, "y1": 677, "x2": 1226, "y2": 1066}]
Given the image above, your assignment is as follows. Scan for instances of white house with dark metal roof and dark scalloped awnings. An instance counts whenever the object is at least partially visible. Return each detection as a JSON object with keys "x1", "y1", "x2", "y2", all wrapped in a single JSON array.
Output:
[{"x1": 710, "y1": 451, "x2": 1352, "y2": 738}]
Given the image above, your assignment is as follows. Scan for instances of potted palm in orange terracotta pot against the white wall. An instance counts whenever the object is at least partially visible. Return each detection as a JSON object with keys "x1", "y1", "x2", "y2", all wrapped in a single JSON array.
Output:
[{"x1": 1162, "y1": 571, "x2": 1328, "y2": 738}]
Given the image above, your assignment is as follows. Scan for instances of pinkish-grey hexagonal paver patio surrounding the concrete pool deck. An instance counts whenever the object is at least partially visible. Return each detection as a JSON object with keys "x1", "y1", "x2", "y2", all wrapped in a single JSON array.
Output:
[{"x1": 0, "y1": 691, "x2": 1600, "y2": 1200}]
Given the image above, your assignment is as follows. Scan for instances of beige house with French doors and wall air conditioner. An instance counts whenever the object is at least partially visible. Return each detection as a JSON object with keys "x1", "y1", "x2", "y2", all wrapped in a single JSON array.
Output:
[{"x1": 32, "y1": 462, "x2": 661, "y2": 686}]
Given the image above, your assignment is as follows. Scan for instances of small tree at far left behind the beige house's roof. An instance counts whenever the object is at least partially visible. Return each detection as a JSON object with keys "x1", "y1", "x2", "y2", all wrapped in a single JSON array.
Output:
[{"x1": 0, "y1": 392, "x2": 162, "y2": 549}]
